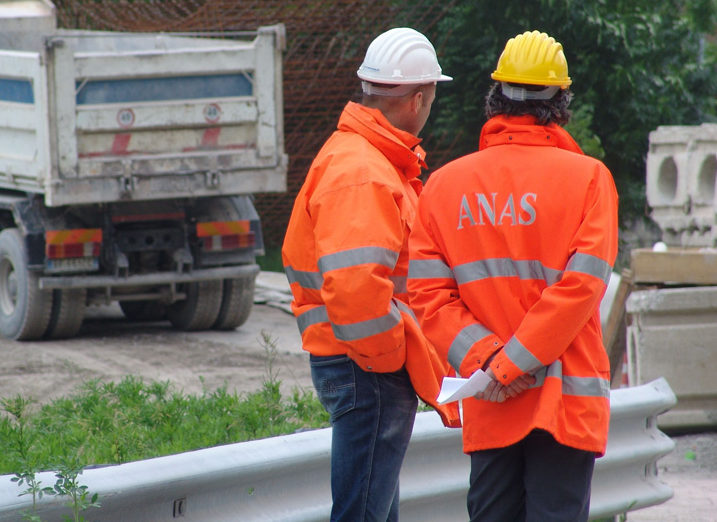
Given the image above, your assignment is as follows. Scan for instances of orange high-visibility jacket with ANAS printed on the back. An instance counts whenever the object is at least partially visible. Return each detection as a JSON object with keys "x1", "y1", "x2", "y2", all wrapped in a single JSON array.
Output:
[{"x1": 408, "y1": 116, "x2": 617, "y2": 454}]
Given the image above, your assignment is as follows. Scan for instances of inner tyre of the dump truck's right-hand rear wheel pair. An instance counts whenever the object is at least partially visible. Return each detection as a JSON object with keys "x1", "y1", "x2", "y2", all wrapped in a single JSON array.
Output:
[{"x1": 167, "y1": 280, "x2": 222, "y2": 331}]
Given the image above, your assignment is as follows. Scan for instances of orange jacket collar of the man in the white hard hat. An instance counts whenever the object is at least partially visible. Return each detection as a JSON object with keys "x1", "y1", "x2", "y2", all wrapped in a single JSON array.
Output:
[{"x1": 338, "y1": 102, "x2": 426, "y2": 179}]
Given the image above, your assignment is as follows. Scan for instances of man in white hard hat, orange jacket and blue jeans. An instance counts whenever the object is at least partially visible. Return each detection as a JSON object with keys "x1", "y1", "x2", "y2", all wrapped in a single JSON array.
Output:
[{"x1": 282, "y1": 27, "x2": 459, "y2": 522}]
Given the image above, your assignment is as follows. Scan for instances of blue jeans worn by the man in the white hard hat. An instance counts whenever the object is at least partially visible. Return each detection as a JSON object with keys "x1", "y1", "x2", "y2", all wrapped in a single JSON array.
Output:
[{"x1": 311, "y1": 355, "x2": 418, "y2": 522}]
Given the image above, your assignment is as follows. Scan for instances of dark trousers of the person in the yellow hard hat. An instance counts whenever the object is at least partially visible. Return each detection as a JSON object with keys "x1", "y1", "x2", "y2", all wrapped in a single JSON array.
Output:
[{"x1": 468, "y1": 430, "x2": 595, "y2": 522}]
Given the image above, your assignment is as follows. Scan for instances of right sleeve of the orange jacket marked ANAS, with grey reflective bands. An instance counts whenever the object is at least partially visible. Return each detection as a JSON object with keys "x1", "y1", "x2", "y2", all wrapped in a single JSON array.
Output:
[{"x1": 490, "y1": 164, "x2": 618, "y2": 384}]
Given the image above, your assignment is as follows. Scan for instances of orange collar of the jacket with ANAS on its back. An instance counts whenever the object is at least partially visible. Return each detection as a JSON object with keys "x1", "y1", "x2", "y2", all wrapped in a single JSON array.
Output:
[{"x1": 478, "y1": 115, "x2": 583, "y2": 154}]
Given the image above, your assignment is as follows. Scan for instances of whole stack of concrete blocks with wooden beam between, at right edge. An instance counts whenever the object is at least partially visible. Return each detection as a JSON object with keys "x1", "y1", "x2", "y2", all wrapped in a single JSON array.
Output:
[{"x1": 626, "y1": 123, "x2": 717, "y2": 429}]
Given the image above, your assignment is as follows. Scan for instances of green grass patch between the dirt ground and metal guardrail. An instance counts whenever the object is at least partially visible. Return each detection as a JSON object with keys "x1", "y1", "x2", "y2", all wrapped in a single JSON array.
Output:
[{"x1": 0, "y1": 332, "x2": 328, "y2": 474}]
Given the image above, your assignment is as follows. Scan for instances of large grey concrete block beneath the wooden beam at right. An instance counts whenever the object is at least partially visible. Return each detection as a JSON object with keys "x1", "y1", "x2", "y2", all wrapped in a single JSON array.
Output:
[{"x1": 626, "y1": 286, "x2": 717, "y2": 429}]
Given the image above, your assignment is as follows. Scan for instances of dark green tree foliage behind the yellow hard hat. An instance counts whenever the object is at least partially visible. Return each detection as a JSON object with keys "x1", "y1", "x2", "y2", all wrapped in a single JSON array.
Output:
[{"x1": 431, "y1": 0, "x2": 717, "y2": 222}]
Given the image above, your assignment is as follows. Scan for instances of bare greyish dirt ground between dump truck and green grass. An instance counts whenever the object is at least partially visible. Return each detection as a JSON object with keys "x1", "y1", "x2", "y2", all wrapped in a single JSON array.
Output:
[{"x1": 0, "y1": 270, "x2": 313, "y2": 403}]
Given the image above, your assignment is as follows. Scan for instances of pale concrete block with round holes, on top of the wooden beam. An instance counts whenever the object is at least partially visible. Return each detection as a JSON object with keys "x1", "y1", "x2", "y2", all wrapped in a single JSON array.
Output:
[{"x1": 647, "y1": 123, "x2": 717, "y2": 247}]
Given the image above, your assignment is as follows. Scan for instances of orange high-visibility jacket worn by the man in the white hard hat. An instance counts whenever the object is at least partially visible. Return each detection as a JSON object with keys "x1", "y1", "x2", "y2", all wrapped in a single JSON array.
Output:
[{"x1": 282, "y1": 102, "x2": 460, "y2": 426}]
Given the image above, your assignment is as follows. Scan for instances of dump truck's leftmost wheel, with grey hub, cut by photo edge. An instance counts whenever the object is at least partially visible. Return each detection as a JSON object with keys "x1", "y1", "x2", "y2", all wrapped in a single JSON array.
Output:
[{"x1": 0, "y1": 228, "x2": 52, "y2": 341}]
